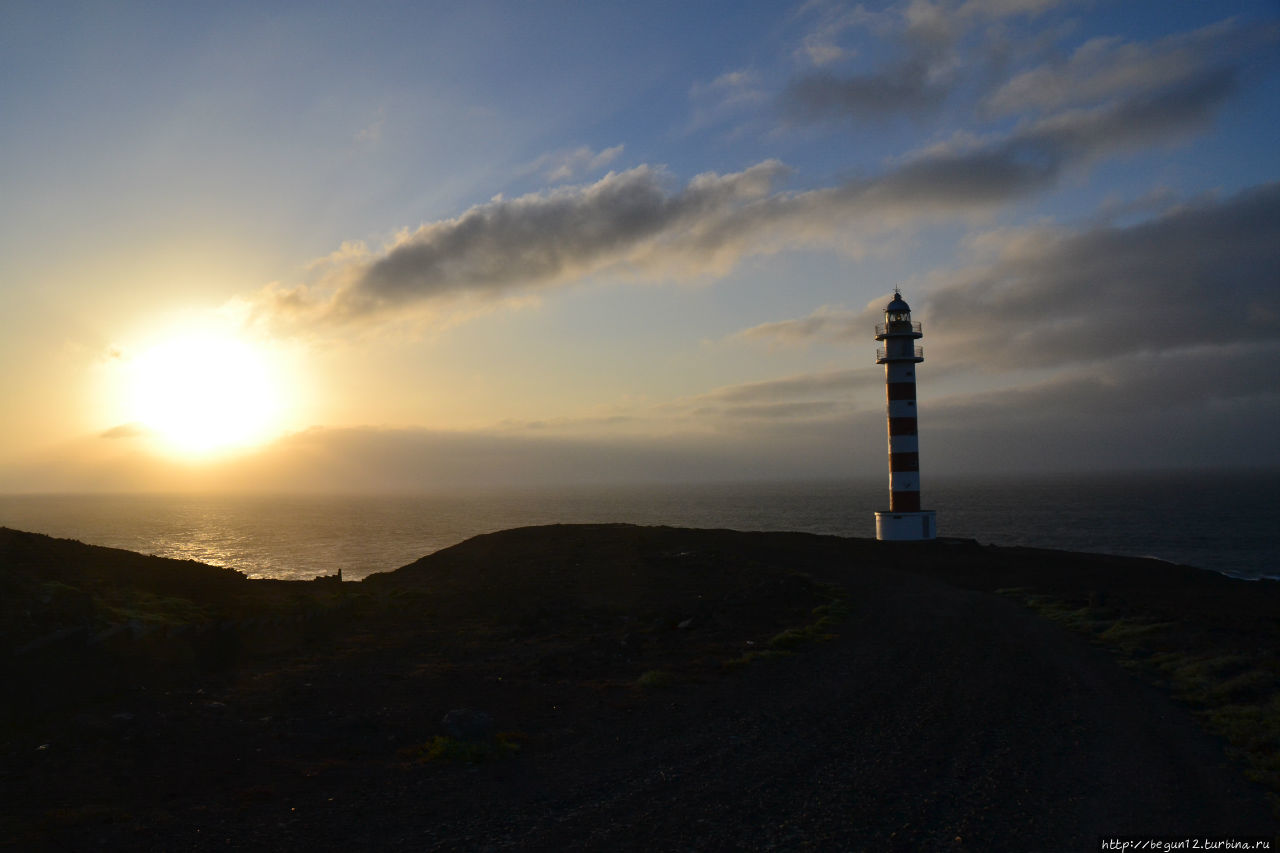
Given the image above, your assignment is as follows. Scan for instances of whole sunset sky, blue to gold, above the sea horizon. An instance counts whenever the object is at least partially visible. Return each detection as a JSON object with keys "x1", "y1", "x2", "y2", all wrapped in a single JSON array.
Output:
[{"x1": 0, "y1": 0, "x2": 1280, "y2": 493}]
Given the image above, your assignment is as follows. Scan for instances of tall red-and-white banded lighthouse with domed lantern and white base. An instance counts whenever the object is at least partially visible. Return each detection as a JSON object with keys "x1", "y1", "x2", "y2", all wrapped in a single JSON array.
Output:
[{"x1": 876, "y1": 287, "x2": 938, "y2": 542}]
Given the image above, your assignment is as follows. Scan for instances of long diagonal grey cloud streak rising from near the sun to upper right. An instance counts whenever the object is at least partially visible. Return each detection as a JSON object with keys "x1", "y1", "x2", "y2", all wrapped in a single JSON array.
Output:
[{"x1": 247, "y1": 70, "x2": 1235, "y2": 325}]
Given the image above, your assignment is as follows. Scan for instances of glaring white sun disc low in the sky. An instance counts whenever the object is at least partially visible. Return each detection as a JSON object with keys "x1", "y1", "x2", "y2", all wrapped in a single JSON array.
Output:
[{"x1": 128, "y1": 332, "x2": 284, "y2": 456}]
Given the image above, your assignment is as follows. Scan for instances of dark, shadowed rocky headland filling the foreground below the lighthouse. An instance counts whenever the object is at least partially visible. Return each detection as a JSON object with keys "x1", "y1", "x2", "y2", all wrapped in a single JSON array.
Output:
[{"x1": 0, "y1": 525, "x2": 1280, "y2": 850}]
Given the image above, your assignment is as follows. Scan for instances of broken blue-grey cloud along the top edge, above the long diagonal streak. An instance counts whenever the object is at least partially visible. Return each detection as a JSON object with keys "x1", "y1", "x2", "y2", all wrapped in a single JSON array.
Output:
[{"x1": 778, "y1": 1, "x2": 1280, "y2": 136}]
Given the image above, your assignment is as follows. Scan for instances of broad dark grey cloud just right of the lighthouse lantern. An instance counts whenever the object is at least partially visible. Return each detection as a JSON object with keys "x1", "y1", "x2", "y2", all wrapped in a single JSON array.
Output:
[{"x1": 927, "y1": 183, "x2": 1280, "y2": 368}]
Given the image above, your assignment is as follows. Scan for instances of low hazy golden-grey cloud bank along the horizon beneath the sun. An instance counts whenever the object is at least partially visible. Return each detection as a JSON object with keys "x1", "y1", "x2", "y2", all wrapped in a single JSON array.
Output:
[{"x1": 0, "y1": 419, "x2": 882, "y2": 494}]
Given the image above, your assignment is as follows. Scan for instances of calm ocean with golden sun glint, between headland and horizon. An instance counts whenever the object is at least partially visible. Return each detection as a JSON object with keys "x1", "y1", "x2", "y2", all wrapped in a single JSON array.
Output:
[{"x1": 0, "y1": 471, "x2": 1280, "y2": 580}]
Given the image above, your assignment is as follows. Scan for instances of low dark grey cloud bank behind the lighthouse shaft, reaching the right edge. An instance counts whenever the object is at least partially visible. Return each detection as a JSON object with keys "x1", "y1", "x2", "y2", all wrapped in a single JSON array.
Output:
[{"x1": 686, "y1": 343, "x2": 1280, "y2": 471}]
